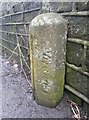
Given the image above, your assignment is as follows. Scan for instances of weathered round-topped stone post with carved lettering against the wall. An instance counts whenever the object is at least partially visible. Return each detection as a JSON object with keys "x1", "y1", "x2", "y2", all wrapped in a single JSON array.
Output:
[{"x1": 30, "y1": 13, "x2": 67, "y2": 107}]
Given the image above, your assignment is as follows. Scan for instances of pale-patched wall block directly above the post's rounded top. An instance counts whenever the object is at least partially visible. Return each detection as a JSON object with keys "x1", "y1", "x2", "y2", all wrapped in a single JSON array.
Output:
[{"x1": 42, "y1": 2, "x2": 72, "y2": 12}]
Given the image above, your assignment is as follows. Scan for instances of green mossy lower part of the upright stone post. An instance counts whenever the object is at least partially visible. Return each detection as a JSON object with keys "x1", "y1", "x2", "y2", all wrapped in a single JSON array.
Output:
[{"x1": 34, "y1": 66, "x2": 64, "y2": 107}]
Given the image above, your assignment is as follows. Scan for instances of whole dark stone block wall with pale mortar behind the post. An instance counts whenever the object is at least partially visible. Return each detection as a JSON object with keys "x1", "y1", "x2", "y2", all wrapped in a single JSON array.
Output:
[{"x1": 0, "y1": 2, "x2": 89, "y2": 112}]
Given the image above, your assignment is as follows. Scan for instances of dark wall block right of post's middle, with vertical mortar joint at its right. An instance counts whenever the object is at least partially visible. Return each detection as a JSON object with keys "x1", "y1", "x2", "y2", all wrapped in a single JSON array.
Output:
[{"x1": 66, "y1": 42, "x2": 84, "y2": 67}]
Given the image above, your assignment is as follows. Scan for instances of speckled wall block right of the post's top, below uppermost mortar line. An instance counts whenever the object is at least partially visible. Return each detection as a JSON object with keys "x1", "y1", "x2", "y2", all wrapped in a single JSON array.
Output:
[{"x1": 66, "y1": 17, "x2": 89, "y2": 40}]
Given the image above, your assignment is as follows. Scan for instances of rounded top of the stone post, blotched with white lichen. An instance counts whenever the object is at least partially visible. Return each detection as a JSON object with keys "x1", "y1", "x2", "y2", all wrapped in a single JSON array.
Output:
[{"x1": 30, "y1": 13, "x2": 67, "y2": 26}]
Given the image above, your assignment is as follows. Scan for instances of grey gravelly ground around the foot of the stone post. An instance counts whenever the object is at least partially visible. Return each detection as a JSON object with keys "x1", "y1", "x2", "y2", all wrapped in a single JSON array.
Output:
[{"x1": 0, "y1": 56, "x2": 87, "y2": 118}]
